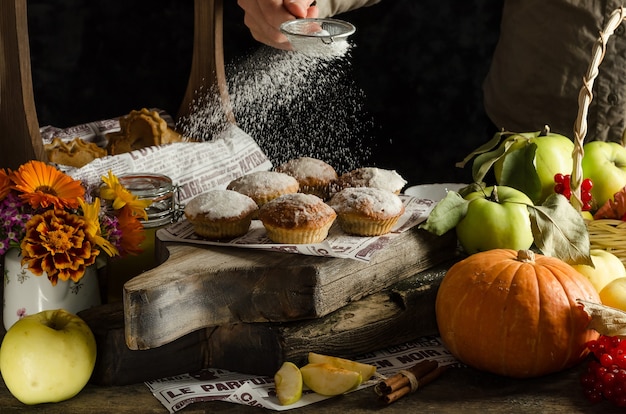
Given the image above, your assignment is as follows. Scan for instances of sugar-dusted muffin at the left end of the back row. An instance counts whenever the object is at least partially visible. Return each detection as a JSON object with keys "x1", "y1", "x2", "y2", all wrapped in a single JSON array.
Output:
[{"x1": 226, "y1": 171, "x2": 300, "y2": 212}]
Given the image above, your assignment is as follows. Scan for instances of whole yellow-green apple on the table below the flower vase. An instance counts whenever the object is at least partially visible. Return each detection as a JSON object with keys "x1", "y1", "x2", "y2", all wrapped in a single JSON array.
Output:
[{"x1": 0, "y1": 309, "x2": 96, "y2": 405}]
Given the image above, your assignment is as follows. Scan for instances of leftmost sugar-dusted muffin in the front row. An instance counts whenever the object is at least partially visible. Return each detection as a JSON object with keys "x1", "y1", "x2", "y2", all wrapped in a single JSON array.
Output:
[{"x1": 185, "y1": 190, "x2": 258, "y2": 239}]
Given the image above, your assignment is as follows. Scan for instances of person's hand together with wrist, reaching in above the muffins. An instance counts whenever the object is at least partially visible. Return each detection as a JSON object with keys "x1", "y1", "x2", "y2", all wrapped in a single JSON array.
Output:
[{"x1": 237, "y1": 0, "x2": 380, "y2": 50}]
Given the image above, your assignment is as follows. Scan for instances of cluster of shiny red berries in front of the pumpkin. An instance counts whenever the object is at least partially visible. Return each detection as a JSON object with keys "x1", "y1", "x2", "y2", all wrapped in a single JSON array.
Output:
[{"x1": 580, "y1": 335, "x2": 626, "y2": 407}]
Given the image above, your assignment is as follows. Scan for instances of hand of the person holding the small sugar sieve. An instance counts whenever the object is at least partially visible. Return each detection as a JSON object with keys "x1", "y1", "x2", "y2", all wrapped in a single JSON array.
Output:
[{"x1": 237, "y1": 0, "x2": 318, "y2": 50}]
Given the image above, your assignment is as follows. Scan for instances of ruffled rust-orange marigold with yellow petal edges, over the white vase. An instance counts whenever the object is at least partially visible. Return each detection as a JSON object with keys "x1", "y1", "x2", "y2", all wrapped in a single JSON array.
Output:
[{"x1": 20, "y1": 210, "x2": 100, "y2": 286}]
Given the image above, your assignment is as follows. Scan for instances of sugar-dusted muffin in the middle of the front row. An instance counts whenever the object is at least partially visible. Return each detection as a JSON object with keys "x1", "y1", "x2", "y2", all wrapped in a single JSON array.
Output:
[{"x1": 259, "y1": 193, "x2": 337, "y2": 244}]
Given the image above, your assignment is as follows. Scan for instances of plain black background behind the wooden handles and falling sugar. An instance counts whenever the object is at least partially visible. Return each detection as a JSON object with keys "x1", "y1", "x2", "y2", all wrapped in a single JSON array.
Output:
[{"x1": 28, "y1": 0, "x2": 502, "y2": 184}]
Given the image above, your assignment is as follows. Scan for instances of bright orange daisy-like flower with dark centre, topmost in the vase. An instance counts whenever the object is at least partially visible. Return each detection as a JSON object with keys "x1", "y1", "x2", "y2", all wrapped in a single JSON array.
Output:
[{"x1": 10, "y1": 161, "x2": 85, "y2": 209}]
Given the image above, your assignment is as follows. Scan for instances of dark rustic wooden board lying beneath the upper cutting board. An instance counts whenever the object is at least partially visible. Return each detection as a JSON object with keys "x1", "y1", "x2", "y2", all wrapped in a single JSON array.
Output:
[{"x1": 79, "y1": 261, "x2": 452, "y2": 385}]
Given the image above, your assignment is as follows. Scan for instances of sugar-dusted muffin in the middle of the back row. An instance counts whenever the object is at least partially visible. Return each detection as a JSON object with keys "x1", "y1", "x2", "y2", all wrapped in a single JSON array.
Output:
[{"x1": 275, "y1": 157, "x2": 338, "y2": 200}]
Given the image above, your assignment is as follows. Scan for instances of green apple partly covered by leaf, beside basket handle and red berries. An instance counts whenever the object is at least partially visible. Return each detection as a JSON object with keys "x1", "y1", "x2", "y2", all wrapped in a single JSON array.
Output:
[{"x1": 493, "y1": 131, "x2": 574, "y2": 205}]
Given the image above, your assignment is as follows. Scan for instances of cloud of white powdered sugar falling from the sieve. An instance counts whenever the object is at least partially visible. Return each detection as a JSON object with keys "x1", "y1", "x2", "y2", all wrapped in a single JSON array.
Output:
[{"x1": 179, "y1": 41, "x2": 373, "y2": 171}]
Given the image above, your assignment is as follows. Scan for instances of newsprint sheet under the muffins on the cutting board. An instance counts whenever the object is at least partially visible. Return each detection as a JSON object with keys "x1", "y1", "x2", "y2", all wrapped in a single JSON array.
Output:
[{"x1": 157, "y1": 195, "x2": 435, "y2": 262}]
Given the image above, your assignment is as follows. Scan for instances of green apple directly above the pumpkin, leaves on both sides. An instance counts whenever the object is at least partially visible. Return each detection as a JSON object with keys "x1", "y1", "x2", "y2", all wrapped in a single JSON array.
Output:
[{"x1": 456, "y1": 186, "x2": 534, "y2": 254}]
